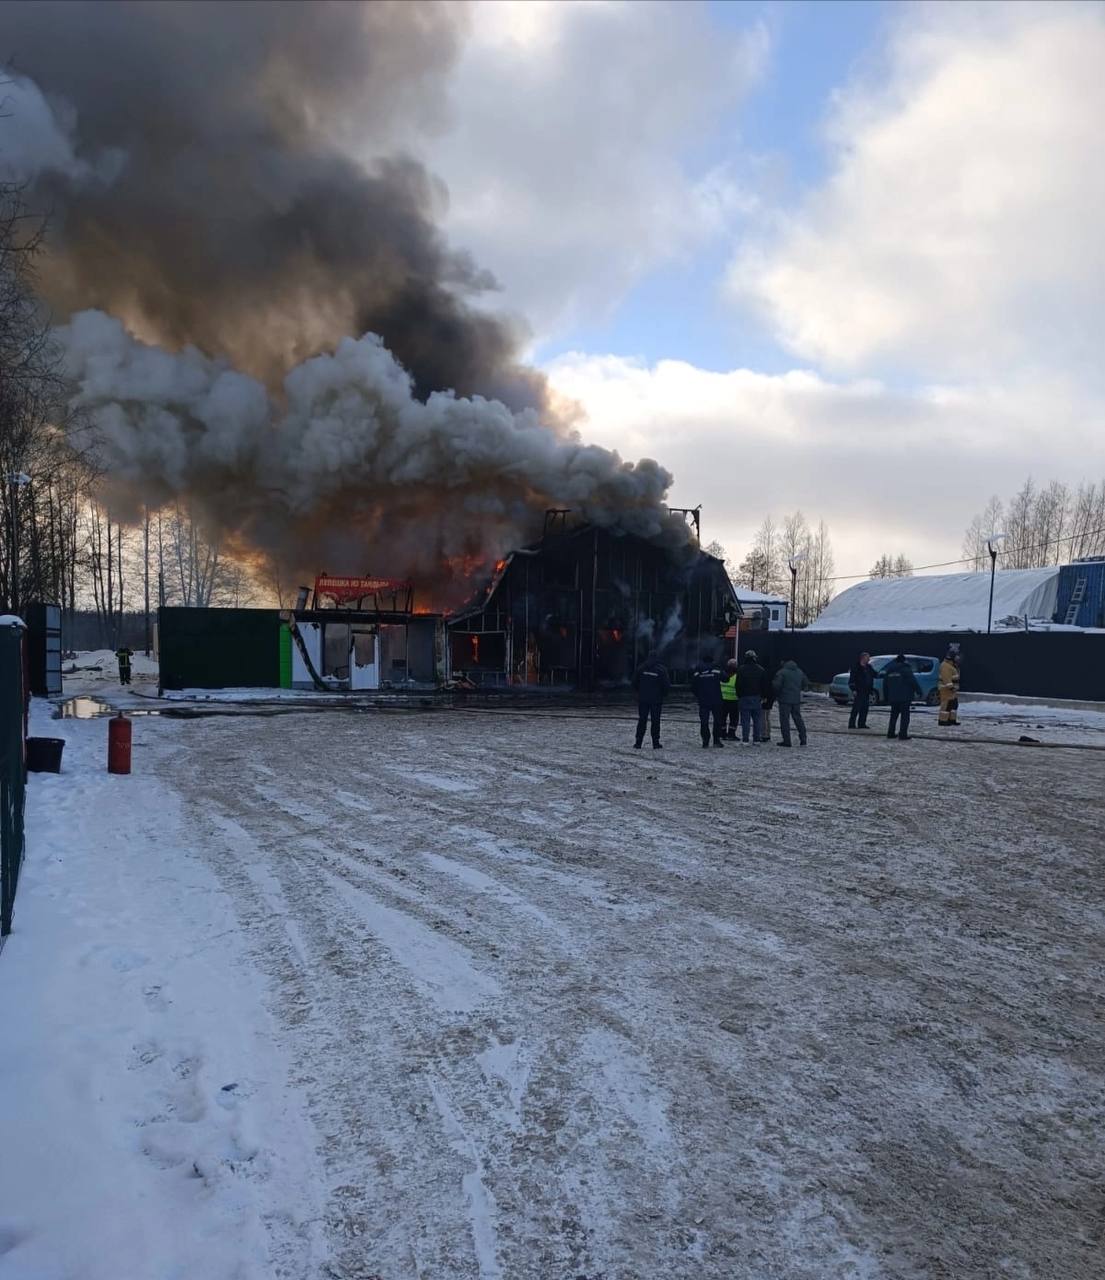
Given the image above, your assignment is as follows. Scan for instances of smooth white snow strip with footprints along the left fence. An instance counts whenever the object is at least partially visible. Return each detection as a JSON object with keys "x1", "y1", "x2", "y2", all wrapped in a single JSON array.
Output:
[{"x1": 0, "y1": 703, "x2": 321, "y2": 1280}]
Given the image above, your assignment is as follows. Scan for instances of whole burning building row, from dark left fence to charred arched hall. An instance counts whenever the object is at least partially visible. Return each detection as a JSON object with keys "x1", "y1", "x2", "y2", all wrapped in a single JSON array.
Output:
[{"x1": 159, "y1": 511, "x2": 741, "y2": 691}]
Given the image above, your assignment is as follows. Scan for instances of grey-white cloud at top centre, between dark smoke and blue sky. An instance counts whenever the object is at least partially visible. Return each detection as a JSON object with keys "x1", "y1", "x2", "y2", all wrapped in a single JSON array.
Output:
[{"x1": 411, "y1": 0, "x2": 767, "y2": 337}]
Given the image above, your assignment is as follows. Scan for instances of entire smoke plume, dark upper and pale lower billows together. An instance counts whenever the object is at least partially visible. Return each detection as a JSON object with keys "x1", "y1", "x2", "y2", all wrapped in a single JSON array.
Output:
[{"x1": 0, "y1": 0, "x2": 686, "y2": 599}]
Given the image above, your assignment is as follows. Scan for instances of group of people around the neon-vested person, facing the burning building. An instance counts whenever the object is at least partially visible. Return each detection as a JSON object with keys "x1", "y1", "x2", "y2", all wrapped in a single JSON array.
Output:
[{"x1": 633, "y1": 649, "x2": 809, "y2": 750}]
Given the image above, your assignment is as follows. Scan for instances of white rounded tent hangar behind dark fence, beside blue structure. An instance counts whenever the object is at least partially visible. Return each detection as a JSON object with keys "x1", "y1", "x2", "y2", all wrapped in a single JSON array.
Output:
[{"x1": 808, "y1": 568, "x2": 1059, "y2": 631}]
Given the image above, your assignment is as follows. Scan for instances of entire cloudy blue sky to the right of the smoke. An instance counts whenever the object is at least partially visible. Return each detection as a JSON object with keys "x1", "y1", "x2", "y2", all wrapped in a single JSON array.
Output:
[{"x1": 411, "y1": 0, "x2": 1105, "y2": 573}]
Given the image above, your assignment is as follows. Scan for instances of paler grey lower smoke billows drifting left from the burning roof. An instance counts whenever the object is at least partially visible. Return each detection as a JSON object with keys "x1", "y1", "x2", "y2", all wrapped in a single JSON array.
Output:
[{"x1": 60, "y1": 311, "x2": 684, "y2": 607}]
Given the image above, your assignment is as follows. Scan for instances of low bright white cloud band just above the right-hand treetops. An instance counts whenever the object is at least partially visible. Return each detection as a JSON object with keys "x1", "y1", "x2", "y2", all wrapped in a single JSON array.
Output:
[{"x1": 547, "y1": 353, "x2": 1105, "y2": 572}]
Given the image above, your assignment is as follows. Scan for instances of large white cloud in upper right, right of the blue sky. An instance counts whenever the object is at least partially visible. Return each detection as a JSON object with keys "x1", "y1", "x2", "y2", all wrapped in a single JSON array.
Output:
[{"x1": 729, "y1": 4, "x2": 1105, "y2": 378}]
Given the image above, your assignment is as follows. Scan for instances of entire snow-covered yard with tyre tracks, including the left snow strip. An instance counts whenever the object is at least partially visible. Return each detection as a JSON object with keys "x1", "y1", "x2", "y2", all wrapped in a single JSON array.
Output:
[{"x1": 0, "y1": 704, "x2": 1105, "y2": 1280}]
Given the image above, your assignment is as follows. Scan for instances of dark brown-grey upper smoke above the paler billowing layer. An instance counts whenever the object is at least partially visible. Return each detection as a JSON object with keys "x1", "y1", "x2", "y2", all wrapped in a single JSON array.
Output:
[{"x1": 0, "y1": 0, "x2": 542, "y2": 406}]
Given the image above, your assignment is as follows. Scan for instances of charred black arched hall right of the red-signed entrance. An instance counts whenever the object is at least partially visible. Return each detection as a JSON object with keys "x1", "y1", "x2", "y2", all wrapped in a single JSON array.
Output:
[{"x1": 446, "y1": 511, "x2": 741, "y2": 690}]
